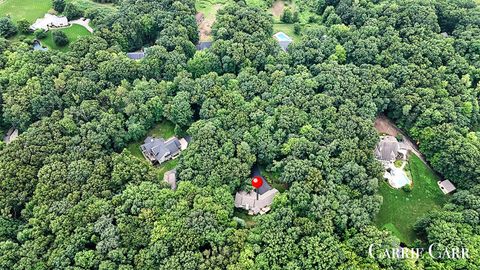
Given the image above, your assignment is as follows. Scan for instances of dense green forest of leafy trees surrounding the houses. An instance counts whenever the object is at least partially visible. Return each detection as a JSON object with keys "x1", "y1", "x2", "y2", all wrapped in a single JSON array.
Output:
[{"x1": 0, "y1": 0, "x2": 480, "y2": 270}]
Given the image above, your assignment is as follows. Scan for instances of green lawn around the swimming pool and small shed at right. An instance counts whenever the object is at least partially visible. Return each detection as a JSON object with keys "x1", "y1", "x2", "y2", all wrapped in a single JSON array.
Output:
[{"x1": 375, "y1": 155, "x2": 448, "y2": 245}]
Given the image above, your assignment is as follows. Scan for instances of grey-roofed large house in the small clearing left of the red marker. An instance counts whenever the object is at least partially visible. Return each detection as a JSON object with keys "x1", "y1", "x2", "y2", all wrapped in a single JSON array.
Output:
[{"x1": 140, "y1": 137, "x2": 188, "y2": 164}]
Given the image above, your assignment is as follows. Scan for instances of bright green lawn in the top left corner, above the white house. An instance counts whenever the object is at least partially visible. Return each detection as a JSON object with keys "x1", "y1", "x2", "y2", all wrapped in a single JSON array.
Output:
[{"x1": 0, "y1": 0, "x2": 52, "y2": 23}]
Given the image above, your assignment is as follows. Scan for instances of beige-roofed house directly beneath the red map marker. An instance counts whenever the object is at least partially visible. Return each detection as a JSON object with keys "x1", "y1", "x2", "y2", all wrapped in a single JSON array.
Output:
[{"x1": 235, "y1": 177, "x2": 278, "y2": 215}]
